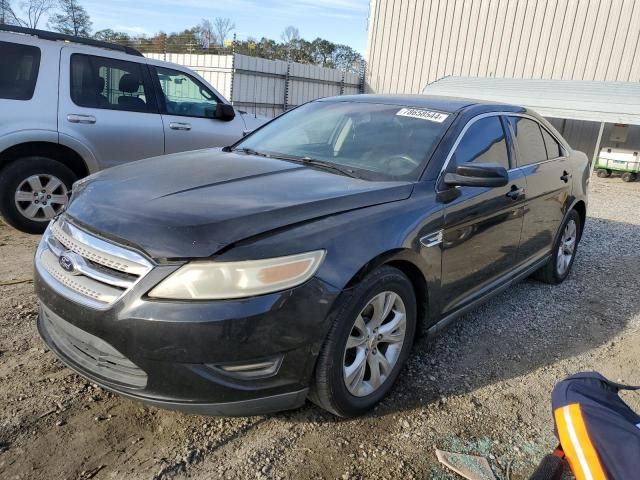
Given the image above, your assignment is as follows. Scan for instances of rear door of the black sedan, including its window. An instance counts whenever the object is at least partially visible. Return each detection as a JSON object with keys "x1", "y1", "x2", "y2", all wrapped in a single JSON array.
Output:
[{"x1": 508, "y1": 116, "x2": 572, "y2": 264}]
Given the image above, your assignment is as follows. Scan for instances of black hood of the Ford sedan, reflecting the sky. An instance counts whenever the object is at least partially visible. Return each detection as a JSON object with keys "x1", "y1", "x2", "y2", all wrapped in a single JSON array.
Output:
[{"x1": 67, "y1": 149, "x2": 413, "y2": 258}]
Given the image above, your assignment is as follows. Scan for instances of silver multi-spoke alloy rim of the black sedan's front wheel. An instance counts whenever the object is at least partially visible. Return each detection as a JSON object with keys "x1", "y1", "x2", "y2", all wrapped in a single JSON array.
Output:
[{"x1": 343, "y1": 291, "x2": 407, "y2": 397}]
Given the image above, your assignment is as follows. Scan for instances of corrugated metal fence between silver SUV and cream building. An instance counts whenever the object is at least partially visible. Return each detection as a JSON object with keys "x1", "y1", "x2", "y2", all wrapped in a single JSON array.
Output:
[{"x1": 145, "y1": 53, "x2": 363, "y2": 117}]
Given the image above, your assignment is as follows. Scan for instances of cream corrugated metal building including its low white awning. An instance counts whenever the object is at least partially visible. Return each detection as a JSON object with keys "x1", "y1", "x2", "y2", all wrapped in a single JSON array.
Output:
[{"x1": 366, "y1": 0, "x2": 640, "y2": 163}]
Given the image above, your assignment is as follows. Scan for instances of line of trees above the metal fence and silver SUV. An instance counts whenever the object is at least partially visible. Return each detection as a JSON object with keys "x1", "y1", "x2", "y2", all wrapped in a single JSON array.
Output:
[{"x1": 0, "y1": 0, "x2": 364, "y2": 73}]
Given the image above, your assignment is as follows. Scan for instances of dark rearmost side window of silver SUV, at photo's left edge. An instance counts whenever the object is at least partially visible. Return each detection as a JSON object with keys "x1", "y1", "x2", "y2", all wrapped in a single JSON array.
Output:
[{"x1": 0, "y1": 42, "x2": 40, "y2": 100}]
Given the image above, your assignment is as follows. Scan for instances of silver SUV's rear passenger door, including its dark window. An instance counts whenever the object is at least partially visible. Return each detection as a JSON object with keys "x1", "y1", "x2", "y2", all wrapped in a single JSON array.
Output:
[{"x1": 58, "y1": 47, "x2": 164, "y2": 168}]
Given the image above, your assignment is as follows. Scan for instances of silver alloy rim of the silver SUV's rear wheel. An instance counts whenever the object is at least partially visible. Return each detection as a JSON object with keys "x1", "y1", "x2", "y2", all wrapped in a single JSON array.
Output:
[{"x1": 15, "y1": 174, "x2": 69, "y2": 222}]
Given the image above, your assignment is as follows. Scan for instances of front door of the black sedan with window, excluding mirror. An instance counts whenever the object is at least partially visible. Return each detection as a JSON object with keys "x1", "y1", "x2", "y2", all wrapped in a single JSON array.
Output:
[{"x1": 439, "y1": 115, "x2": 526, "y2": 315}]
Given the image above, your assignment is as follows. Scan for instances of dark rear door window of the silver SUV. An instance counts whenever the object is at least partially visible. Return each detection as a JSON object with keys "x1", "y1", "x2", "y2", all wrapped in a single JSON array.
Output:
[{"x1": 71, "y1": 53, "x2": 155, "y2": 112}]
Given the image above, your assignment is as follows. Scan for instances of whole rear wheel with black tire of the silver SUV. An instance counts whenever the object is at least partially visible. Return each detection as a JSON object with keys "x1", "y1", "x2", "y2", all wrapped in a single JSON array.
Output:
[{"x1": 0, "y1": 156, "x2": 77, "y2": 234}]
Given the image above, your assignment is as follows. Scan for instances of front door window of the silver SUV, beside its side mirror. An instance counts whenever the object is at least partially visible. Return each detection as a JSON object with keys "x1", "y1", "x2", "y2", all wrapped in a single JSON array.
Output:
[{"x1": 155, "y1": 67, "x2": 218, "y2": 118}]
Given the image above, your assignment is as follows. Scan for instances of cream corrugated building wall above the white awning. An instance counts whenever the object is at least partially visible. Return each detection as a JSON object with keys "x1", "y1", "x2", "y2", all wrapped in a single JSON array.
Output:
[{"x1": 367, "y1": 0, "x2": 640, "y2": 93}]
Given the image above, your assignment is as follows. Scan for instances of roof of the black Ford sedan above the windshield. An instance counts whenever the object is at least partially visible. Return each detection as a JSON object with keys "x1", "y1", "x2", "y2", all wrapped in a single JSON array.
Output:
[{"x1": 319, "y1": 94, "x2": 522, "y2": 113}]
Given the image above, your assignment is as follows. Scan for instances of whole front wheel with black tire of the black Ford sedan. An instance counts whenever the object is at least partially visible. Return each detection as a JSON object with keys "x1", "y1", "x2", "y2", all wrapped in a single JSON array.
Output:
[{"x1": 309, "y1": 266, "x2": 417, "y2": 417}]
